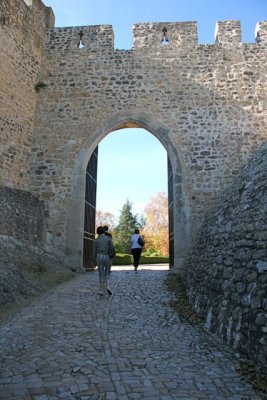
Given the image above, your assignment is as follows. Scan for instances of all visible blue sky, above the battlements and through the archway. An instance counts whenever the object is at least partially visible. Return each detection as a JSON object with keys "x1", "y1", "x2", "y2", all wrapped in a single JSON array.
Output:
[{"x1": 44, "y1": 0, "x2": 267, "y2": 217}]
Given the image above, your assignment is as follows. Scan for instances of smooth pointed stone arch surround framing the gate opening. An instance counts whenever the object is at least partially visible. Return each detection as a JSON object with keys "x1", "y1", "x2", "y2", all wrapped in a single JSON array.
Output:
[{"x1": 65, "y1": 113, "x2": 190, "y2": 267}]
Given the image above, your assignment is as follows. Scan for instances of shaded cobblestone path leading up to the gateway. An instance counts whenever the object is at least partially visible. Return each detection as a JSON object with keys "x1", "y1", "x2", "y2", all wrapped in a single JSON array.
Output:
[{"x1": 0, "y1": 269, "x2": 261, "y2": 400}]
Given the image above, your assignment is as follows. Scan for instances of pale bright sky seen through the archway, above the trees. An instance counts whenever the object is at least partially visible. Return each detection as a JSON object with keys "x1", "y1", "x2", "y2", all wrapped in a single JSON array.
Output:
[{"x1": 96, "y1": 128, "x2": 168, "y2": 222}]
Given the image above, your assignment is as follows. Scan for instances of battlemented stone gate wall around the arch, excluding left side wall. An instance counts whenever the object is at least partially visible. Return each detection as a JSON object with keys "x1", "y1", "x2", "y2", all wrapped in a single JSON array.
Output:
[{"x1": 31, "y1": 21, "x2": 267, "y2": 262}]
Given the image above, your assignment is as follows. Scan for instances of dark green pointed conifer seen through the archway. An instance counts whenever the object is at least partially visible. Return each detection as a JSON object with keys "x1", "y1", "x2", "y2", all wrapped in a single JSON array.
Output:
[{"x1": 114, "y1": 199, "x2": 139, "y2": 253}]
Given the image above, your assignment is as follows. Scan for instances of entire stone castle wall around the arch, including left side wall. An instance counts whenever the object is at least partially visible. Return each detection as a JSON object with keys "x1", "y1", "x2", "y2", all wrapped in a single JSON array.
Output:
[{"x1": 0, "y1": 0, "x2": 267, "y2": 268}]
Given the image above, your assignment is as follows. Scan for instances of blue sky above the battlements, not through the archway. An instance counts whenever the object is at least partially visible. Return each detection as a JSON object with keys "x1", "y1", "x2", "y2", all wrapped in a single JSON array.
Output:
[{"x1": 44, "y1": 0, "x2": 267, "y2": 49}]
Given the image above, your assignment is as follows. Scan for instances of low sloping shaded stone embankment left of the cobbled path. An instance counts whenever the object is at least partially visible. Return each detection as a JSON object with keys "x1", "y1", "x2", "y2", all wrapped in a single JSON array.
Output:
[{"x1": 0, "y1": 235, "x2": 75, "y2": 308}]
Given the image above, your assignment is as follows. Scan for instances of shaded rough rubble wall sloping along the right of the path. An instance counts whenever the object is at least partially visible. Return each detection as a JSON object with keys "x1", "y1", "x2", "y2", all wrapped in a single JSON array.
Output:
[{"x1": 185, "y1": 143, "x2": 267, "y2": 365}]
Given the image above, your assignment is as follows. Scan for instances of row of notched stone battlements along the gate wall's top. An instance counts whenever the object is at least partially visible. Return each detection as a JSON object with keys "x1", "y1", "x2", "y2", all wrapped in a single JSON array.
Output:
[{"x1": 45, "y1": 21, "x2": 267, "y2": 52}]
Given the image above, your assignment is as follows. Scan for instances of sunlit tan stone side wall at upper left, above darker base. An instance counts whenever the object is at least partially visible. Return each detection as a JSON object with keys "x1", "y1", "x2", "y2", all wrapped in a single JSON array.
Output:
[{"x1": 0, "y1": 0, "x2": 54, "y2": 190}]
